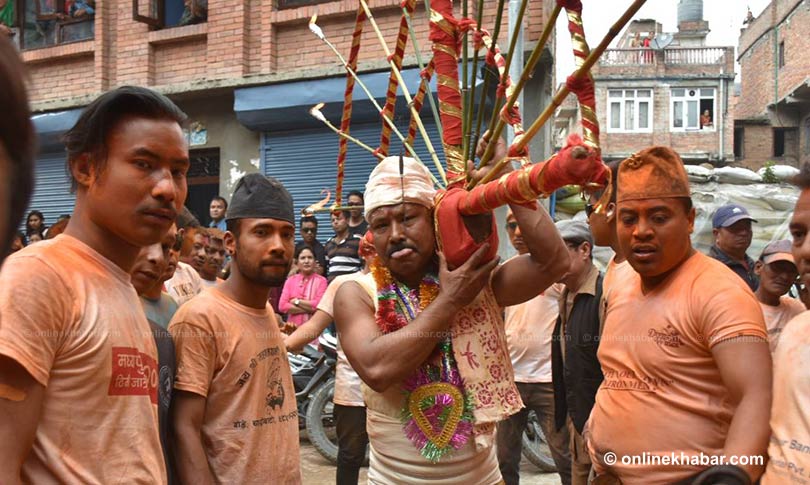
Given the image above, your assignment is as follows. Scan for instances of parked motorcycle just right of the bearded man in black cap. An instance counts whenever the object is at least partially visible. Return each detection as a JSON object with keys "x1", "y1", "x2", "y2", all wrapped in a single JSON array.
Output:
[{"x1": 287, "y1": 332, "x2": 337, "y2": 464}]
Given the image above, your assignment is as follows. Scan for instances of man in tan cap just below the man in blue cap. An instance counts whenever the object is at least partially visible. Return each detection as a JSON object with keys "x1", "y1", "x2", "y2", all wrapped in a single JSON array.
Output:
[{"x1": 754, "y1": 239, "x2": 806, "y2": 352}]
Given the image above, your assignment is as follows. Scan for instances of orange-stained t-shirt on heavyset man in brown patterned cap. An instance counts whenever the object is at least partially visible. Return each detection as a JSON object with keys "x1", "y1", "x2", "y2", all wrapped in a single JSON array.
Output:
[{"x1": 588, "y1": 253, "x2": 768, "y2": 484}]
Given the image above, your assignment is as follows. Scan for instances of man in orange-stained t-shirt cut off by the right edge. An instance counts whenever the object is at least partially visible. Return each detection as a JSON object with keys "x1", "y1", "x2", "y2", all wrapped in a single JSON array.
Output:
[{"x1": 760, "y1": 163, "x2": 810, "y2": 485}]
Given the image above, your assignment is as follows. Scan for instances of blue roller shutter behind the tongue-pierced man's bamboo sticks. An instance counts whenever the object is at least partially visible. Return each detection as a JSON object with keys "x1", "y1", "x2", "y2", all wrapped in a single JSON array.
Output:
[{"x1": 261, "y1": 123, "x2": 444, "y2": 228}]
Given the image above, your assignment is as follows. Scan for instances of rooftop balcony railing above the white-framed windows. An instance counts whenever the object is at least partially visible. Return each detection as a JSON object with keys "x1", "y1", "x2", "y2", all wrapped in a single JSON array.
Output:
[{"x1": 599, "y1": 47, "x2": 733, "y2": 66}]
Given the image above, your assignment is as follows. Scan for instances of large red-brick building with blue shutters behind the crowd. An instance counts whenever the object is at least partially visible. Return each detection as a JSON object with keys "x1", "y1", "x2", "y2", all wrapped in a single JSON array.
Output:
[{"x1": 9, "y1": 0, "x2": 554, "y2": 226}]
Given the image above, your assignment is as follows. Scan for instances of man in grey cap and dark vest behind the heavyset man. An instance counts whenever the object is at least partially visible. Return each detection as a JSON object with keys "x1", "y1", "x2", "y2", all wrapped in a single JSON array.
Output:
[{"x1": 551, "y1": 221, "x2": 603, "y2": 485}]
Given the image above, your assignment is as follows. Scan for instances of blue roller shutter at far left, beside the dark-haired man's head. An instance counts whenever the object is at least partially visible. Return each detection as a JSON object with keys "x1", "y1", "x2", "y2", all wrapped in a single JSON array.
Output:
[{"x1": 22, "y1": 153, "x2": 76, "y2": 228}]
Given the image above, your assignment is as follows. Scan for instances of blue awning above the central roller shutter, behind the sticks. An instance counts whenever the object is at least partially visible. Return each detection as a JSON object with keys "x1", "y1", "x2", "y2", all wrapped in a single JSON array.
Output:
[{"x1": 234, "y1": 65, "x2": 482, "y2": 131}]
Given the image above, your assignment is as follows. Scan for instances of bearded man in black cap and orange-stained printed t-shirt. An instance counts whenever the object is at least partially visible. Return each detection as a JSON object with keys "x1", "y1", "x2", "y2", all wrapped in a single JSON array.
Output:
[{"x1": 169, "y1": 174, "x2": 301, "y2": 484}]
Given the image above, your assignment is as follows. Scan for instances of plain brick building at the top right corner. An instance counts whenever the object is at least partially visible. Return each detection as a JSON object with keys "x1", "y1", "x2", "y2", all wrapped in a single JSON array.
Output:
[{"x1": 734, "y1": 0, "x2": 810, "y2": 169}]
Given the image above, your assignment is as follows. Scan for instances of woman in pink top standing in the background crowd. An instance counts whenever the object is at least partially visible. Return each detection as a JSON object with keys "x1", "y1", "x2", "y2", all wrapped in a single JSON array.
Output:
[{"x1": 278, "y1": 246, "x2": 327, "y2": 327}]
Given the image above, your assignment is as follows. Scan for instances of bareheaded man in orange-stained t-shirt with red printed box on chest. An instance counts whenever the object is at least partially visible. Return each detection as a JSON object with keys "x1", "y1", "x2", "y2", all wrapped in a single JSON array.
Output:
[{"x1": 0, "y1": 87, "x2": 189, "y2": 484}]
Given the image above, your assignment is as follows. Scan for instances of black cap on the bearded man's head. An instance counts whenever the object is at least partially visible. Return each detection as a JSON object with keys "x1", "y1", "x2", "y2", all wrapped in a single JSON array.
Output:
[{"x1": 225, "y1": 173, "x2": 295, "y2": 224}]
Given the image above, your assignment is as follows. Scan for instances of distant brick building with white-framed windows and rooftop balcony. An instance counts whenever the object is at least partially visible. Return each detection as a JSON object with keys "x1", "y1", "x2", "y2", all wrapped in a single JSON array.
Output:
[{"x1": 556, "y1": 0, "x2": 734, "y2": 164}]
